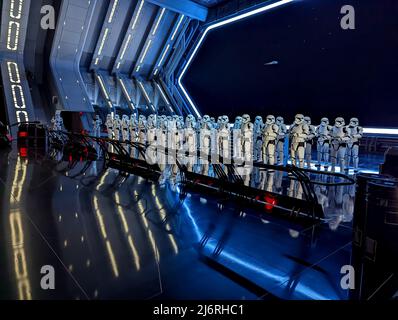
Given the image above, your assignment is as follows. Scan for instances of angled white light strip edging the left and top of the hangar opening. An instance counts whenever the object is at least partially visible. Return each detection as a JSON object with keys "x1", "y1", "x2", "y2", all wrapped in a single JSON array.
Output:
[{"x1": 178, "y1": 0, "x2": 295, "y2": 117}]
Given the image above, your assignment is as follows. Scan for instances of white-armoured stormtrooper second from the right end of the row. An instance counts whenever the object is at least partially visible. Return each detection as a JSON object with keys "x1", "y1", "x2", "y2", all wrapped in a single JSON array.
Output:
[{"x1": 330, "y1": 118, "x2": 350, "y2": 172}]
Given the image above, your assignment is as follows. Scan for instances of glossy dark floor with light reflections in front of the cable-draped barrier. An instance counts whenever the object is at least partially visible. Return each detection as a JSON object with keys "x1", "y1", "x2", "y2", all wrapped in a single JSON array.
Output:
[{"x1": 0, "y1": 146, "x2": 386, "y2": 299}]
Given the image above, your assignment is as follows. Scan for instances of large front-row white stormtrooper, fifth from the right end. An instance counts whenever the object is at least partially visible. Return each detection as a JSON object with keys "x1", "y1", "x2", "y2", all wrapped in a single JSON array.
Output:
[{"x1": 289, "y1": 114, "x2": 309, "y2": 168}]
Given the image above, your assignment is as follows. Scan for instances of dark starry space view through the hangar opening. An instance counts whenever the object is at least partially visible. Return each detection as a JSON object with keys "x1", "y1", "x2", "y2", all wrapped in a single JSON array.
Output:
[{"x1": 184, "y1": 0, "x2": 398, "y2": 127}]
